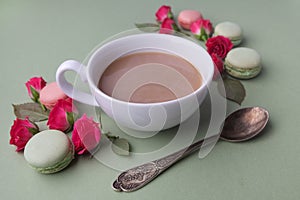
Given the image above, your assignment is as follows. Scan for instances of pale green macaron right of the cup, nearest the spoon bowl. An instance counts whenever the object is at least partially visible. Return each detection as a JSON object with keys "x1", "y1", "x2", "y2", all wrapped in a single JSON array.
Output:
[{"x1": 224, "y1": 47, "x2": 262, "y2": 79}]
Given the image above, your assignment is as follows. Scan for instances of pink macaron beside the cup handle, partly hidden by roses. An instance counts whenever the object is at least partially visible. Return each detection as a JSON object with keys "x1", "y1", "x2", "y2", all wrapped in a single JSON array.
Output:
[{"x1": 40, "y1": 82, "x2": 68, "y2": 110}]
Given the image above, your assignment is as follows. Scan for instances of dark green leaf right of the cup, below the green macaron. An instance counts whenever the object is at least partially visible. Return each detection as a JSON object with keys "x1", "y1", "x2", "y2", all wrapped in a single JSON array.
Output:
[{"x1": 218, "y1": 77, "x2": 246, "y2": 105}]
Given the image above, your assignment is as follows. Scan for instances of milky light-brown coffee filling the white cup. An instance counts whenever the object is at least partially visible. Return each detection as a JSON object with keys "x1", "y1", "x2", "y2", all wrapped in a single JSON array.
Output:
[{"x1": 98, "y1": 51, "x2": 202, "y2": 103}]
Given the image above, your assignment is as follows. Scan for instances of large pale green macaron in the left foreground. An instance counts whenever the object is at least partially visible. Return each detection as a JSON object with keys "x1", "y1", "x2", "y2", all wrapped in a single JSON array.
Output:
[{"x1": 24, "y1": 130, "x2": 74, "y2": 174}]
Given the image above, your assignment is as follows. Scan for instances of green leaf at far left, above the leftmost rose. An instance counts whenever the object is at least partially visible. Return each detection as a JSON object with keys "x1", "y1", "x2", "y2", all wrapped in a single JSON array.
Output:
[{"x1": 13, "y1": 103, "x2": 49, "y2": 122}]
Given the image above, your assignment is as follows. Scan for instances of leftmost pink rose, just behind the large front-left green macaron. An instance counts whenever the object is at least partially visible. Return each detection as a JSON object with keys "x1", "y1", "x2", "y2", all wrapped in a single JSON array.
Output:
[{"x1": 9, "y1": 118, "x2": 39, "y2": 151}]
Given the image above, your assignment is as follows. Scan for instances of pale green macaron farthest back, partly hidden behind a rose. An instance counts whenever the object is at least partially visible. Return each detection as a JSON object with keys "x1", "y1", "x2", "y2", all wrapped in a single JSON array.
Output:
[{"x1": 214, "y1": 21, "x2": 243, "y2": 46}]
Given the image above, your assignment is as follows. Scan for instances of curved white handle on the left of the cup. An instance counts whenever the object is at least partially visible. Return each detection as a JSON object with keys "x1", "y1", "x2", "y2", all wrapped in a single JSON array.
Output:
[{"x1": 56, "y1": 60, "x2": 97, "y2": 106}]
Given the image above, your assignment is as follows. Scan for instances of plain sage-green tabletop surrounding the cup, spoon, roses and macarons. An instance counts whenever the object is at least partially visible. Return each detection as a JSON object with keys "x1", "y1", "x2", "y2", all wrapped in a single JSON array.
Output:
[{"x1": 0, "y1": 0, "x2": 300, "y2": 200}]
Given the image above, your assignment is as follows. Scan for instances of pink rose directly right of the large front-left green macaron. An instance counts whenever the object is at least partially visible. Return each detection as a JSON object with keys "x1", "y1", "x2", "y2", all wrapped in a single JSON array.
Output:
[{"x1": 72, "y1": 114, "x2": 101, "y2": 155}]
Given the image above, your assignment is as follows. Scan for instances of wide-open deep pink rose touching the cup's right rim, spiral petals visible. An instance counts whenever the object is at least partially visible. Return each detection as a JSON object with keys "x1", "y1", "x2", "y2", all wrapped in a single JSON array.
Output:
[{"x1": 205, "y1": 35, "x2": 233, "y2": 59}]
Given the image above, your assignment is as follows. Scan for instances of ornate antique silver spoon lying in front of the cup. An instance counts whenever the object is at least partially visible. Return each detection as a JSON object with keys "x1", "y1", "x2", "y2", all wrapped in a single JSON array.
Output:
[{"x1": 112, "y1": 107, "x2": 269, "y2": 192}]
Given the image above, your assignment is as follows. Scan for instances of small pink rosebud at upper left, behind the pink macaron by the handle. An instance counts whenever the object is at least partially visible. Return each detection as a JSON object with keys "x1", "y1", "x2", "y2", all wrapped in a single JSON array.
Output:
[{"x1": 25, "y1": 77, "x2": 46, "y2": 102}]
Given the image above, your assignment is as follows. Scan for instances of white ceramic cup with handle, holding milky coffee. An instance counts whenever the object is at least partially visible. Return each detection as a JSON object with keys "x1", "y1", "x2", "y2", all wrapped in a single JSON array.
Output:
[{"x1": 56, "y1": 33, "x2": 214, "y2": 132}]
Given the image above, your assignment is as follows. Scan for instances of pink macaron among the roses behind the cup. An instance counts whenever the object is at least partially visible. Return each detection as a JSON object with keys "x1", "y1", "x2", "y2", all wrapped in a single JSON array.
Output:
[{"x1": 177, "y1": 10, "x2": 202, "y2": 30}]
